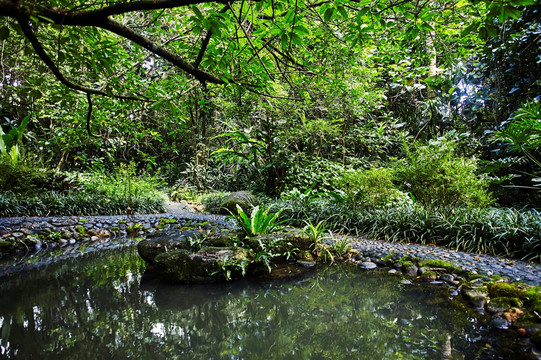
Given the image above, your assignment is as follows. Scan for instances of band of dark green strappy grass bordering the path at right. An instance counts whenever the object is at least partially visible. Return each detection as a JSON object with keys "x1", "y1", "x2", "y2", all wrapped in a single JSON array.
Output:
[{"x1": 266, "y1": 195, "x2": 541, "y2": 262}]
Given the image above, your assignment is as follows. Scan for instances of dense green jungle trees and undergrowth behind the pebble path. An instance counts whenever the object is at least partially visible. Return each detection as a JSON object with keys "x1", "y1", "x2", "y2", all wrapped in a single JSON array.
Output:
[{"x1": 0, "y1": 0, "x2": 541, "y2": 260}]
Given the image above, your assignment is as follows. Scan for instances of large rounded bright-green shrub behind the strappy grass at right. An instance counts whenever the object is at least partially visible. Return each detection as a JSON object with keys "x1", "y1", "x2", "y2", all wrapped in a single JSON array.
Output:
[{"x1": 396, "y1": 135, "x2": 493, "y2": 208}]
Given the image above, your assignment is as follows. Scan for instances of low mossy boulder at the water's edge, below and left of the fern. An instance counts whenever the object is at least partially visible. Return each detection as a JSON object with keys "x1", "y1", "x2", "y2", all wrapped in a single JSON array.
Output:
[{"x1": 152, "y1": 247, "x2": 253, "y2": 284}]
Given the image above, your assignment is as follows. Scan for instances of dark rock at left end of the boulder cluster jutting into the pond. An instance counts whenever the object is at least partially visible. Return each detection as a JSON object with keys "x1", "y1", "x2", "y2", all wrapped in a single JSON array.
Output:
[{"x1": 137, "y1": 230, "x2": 195, "y2": 263}]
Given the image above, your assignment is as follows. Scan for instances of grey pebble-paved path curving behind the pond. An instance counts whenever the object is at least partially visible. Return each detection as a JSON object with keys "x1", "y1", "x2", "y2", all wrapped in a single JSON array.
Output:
[{"x1": 0, "y1": 203, "x2": 541, "y2": 285}]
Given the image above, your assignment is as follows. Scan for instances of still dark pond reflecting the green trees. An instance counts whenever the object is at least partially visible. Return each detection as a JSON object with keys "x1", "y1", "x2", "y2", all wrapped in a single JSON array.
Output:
[{"x1": 0, "y1": 246, "x2": 524, "y2": 359}]
